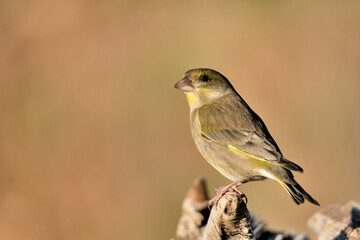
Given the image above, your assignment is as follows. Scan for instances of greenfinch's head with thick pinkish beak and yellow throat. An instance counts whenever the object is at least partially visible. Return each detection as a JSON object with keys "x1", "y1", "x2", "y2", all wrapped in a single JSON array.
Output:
[{"x1": 174, "y1": 68, "x2": 233, "y2": 108}]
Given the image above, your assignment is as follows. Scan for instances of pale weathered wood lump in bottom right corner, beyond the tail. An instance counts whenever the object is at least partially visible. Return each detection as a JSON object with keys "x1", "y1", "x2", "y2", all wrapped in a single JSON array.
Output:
[{"x1": 308, "y1": 202, "x2": 360, "y2": 240}]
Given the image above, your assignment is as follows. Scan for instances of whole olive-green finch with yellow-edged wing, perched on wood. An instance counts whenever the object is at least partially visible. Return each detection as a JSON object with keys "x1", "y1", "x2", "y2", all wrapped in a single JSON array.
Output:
[{"x1": 174, "y1": 68, "x2": 319, "y2": 205}]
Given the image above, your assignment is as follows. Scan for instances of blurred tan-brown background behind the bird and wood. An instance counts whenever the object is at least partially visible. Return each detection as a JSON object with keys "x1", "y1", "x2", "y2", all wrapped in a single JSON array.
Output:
[{"x1": 0, "y1": 0, "x2": 360, "y2": 240}]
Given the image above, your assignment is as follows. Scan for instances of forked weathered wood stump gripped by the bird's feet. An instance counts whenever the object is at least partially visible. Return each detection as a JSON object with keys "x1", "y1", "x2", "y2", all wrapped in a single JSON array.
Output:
[{"x1": 173, "y1": 178, "x2": 308, "y2": 240}]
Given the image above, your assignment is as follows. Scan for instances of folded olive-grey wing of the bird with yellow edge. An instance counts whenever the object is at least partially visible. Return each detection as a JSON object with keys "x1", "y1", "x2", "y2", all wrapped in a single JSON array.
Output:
[{"x1": 198, "y1": 103, "x2": 302, "y2": 172}]
